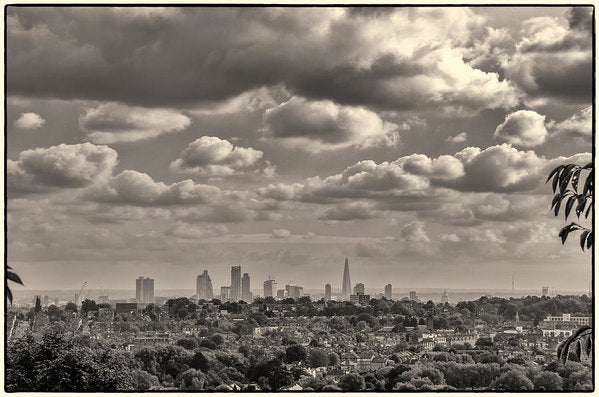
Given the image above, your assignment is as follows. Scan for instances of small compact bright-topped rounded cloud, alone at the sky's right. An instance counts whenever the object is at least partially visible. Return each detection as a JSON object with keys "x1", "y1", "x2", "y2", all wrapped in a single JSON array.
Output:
[{"x1": 493, "y1": 110, "x2": 548, "y2": 147}]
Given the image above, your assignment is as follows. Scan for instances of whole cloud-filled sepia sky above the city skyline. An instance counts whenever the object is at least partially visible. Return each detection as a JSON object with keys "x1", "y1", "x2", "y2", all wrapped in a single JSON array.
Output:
[{"x1": 7, "y1": 7, "x2": 593, "y2": 290}]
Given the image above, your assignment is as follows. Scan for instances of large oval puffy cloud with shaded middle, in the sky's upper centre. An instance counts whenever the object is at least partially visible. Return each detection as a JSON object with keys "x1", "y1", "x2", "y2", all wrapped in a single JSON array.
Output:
[{"x1": 262, "y1": 97, "x2": 399, "y2": 153}]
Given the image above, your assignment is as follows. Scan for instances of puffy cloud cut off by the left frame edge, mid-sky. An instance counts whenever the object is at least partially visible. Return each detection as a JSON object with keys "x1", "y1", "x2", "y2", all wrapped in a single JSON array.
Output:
[{"x1": 7, "y1": 143, "x2": 117, "y2": 194}]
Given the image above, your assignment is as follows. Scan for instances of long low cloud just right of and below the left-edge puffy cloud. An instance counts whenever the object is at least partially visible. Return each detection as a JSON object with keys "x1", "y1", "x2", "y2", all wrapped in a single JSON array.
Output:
[{"x1": 91, "y1": 170, "x2": 223, "y2": 206}]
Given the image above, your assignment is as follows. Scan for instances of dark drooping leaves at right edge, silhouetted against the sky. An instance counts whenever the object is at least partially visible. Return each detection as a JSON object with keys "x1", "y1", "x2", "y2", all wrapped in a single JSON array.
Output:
[{"x1": 547, "y1": 163, "x2": 595, "y2": 251}]
